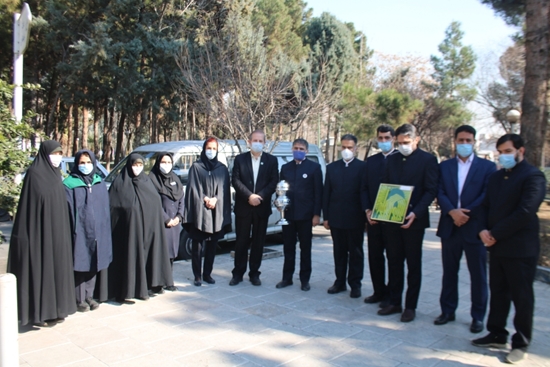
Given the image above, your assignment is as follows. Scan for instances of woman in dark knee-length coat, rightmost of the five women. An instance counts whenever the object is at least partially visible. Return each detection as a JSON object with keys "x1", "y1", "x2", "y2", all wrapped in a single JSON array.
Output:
[{"x1": 183, "y1": 138, "x2": 231, "y2": 286}]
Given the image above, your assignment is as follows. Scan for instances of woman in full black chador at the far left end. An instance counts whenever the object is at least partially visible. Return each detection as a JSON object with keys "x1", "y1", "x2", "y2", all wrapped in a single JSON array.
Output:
[{"x1": 7, "y1": 140, "x2": 76, "y2": 326}]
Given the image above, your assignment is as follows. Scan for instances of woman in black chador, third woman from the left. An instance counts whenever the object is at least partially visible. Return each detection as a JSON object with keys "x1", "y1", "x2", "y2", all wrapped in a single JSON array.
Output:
[{"x1": 109, "y1": 153, "x2": 173, "y2": 303}]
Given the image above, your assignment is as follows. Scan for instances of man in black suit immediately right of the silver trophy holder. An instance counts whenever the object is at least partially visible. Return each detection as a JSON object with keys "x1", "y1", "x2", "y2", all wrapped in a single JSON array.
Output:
[{"x1": 323, "y1": 134, "x2": 366, "y2": 298}]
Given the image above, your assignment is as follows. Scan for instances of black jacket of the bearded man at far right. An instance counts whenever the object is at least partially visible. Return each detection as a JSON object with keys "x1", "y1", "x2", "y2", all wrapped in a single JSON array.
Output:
[{"x1": 477, "y1": 160, "x2": 546, "y2": 257}]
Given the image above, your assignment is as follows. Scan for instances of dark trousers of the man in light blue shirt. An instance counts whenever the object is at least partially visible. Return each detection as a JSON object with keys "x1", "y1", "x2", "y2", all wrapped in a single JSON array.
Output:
[{"x1": 439, "y1": 228, "x2": 489, "y2": 321}]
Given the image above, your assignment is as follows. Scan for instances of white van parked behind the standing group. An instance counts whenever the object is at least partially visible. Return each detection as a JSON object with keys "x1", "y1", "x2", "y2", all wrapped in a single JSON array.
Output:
[{"x1": 105, "y1": 140, "x2": 326, "y2": 260}]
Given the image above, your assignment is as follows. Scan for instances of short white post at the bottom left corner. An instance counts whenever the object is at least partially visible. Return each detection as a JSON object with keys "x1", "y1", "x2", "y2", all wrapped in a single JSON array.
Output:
[{"x1": 0, "y1": 273, "x2": 19, "y2": 367}]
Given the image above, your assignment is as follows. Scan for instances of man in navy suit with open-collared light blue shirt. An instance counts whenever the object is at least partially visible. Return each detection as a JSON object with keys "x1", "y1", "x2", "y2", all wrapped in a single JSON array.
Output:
[{"x1": 434, "y1": 125, "x2": 496, "y2": 333}]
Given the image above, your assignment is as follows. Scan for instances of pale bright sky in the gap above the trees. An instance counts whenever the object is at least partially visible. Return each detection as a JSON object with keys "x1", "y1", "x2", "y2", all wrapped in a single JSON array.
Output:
[{"x1": 306, "y1": 0, "x2": 517, "y2": 58}]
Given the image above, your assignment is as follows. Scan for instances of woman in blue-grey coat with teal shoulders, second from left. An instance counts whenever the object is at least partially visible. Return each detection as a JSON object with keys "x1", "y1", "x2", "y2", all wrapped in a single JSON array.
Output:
[{"x1": 63, "y1": 150, "x2": 113, "y2": 312}]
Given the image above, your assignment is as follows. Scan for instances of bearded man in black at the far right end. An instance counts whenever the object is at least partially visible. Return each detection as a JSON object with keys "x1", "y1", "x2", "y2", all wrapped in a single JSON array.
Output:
[{"x1": 472, "y1": 134, "x2": 546, "y2": 363}]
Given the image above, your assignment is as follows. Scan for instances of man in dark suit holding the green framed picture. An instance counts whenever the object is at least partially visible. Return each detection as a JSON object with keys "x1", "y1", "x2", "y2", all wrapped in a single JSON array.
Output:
[{"x1": 374, "y1": 124, "x2": 439, "y2": 322}]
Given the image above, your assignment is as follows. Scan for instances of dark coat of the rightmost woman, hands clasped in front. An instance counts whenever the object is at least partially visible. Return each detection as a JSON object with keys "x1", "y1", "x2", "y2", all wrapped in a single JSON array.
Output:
[{"x1": 183, "y1": 158, "x2": 231, "y2": 239}]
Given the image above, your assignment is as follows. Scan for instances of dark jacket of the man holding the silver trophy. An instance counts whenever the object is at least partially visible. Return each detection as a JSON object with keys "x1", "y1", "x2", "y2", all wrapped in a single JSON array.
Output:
[{"x1": 279, "y1": 159, "x2": 323, "y2": 220}]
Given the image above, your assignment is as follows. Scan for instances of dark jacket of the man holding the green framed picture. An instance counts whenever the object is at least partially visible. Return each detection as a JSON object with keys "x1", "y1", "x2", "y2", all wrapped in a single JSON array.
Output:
[{"x1": 383, "y1": 149, "x2": 439, "y2": 229}]
